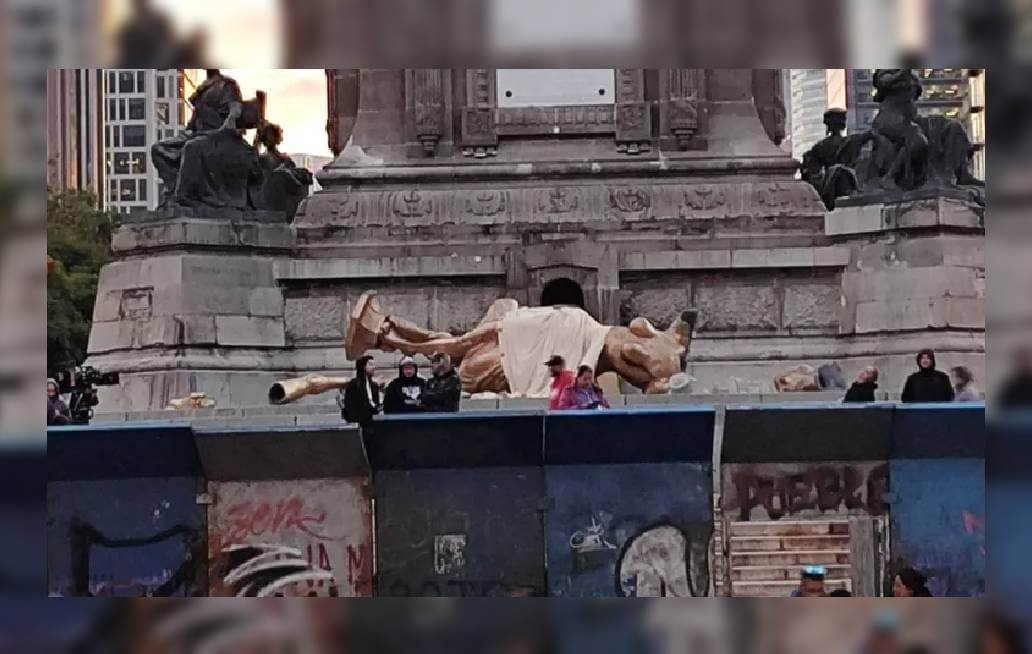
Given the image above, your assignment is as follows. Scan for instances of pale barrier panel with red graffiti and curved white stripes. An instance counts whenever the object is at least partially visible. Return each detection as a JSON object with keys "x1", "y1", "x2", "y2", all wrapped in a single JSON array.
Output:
[{"x1": 208, "y1": 480, "x2": 373, "y2": 597}]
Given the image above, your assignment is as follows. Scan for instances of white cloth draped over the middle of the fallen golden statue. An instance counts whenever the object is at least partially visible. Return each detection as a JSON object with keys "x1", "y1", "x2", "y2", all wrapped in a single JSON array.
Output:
[{"x1": 498, "y1": 306, "x2": 610, "y2": 397}]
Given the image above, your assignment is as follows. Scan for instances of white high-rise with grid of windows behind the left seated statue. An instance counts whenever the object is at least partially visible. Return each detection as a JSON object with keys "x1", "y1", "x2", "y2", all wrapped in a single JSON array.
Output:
[{"x1": 103, "y1": 68, "x2": 196, "y2": 214}]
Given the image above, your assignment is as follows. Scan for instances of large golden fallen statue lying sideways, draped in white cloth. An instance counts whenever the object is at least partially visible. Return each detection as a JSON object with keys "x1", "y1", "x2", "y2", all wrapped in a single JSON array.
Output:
[{"x1": 345, "y1": 291, "x2": 697, "y2": 396}]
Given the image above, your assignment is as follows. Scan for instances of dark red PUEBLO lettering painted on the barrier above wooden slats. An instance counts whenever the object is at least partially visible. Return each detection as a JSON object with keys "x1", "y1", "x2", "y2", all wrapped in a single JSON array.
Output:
[{"x1": 723, "y1": 463, "x2": 889, "y2": 521}]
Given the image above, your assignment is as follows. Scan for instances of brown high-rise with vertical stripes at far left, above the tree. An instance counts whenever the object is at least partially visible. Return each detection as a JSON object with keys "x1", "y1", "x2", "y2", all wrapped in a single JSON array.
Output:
[{"x1": 46, "y1": 68, "x2": 104, "y2": 199}]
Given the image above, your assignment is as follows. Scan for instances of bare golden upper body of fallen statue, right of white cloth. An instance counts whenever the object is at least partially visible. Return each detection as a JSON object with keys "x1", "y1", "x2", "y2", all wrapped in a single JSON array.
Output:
[{"x1": 617, "y1": 310, "x2": 698, "y2": 393}]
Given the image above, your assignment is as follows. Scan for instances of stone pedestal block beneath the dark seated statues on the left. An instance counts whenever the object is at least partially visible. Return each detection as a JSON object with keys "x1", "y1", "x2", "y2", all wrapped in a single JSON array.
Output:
[{"x1": 88, "y1": 209, "x2": 294, "y2": 411}]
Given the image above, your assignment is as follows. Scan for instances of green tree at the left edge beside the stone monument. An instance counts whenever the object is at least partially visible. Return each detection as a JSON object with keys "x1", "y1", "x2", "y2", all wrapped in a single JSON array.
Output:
[{"x1": 46, "y1": 190, "x2": 116, "y2": 370}]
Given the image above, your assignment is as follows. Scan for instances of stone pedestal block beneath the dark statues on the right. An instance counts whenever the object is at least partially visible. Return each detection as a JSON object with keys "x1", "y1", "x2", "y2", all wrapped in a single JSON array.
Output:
[{"x1": 825, "y1": 191, "x2": 986, "y2": 381}]
